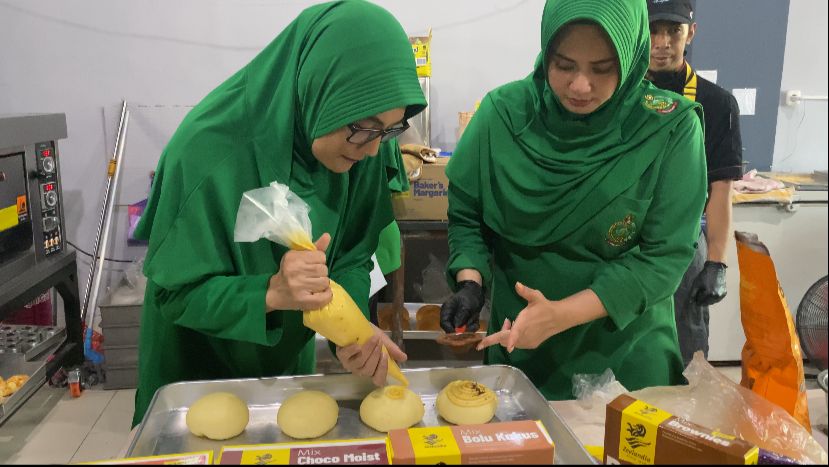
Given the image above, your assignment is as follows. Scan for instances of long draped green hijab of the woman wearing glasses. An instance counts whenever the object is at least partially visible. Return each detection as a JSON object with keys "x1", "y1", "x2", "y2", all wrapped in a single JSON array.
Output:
[{"x1": 136, "y1": 0, "x2": 426, "y2": 314}]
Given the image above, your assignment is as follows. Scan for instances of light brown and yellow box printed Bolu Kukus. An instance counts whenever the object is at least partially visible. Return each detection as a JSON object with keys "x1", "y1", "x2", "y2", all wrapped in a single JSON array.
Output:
[{"x1": 388, "y1": 420, "x2": 555, "y2": 465}]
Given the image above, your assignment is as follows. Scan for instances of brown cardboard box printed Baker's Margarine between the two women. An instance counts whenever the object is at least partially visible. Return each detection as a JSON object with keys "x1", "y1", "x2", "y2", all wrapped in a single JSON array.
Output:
[{"x1": 392, "y1": 157, "x2": 450, "y2": 221}]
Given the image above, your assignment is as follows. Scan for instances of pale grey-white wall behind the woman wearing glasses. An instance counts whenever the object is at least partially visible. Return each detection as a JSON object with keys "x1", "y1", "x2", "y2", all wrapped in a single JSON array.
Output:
[{"x1": 0, "y1": 0, "x2": 544, "y2": 287}]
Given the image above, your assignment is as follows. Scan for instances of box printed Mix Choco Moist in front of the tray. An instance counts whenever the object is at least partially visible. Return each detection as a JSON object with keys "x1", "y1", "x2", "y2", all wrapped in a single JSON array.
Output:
[{"x1": 218, "y1": 438, "x2": 389, "y2": 465}]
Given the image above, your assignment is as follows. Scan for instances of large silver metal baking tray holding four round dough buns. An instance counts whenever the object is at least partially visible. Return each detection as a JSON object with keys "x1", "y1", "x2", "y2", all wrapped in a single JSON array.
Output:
[{"x1": 127, "y1": 365, "x2": 595, "y2": 464}]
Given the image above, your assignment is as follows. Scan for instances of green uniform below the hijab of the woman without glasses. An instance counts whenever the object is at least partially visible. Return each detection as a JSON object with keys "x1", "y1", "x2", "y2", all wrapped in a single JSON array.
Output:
[{"x1": 449, "y1": 88, "x2": 706, "y2": 400}]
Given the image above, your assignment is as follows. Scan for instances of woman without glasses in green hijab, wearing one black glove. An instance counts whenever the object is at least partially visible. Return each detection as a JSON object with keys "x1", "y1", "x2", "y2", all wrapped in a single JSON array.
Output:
[{"x1": 441, "y1": 0, "x2": 706, "y2": 400}]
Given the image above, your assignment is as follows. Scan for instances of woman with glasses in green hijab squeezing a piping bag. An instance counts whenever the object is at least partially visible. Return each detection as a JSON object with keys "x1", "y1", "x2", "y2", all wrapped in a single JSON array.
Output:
[{"x1": 133, "y1": 0, "x2": 426, "y2": 425}]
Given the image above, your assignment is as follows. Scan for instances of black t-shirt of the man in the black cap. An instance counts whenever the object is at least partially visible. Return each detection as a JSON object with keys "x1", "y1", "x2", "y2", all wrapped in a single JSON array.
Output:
[{"x1": 648, "y1": 66, "x2": 743, "y2": 185}]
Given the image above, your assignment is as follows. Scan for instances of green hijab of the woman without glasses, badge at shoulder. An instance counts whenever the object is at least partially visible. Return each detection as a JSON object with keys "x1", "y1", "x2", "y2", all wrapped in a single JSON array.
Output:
[{"x1": 447, "y1": 0, "x2": 694, "y2": 246}]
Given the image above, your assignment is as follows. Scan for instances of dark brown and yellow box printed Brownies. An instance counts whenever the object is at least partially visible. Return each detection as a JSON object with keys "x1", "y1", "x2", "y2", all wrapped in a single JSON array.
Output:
[{"x1": 604, "y1": 394, "x2": 759, "y2": 465}]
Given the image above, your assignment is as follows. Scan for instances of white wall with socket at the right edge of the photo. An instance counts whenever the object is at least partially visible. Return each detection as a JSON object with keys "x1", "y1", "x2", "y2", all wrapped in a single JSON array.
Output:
[{"x1": 772, "y1": 0, "x2": 829, "y2": 172}]
